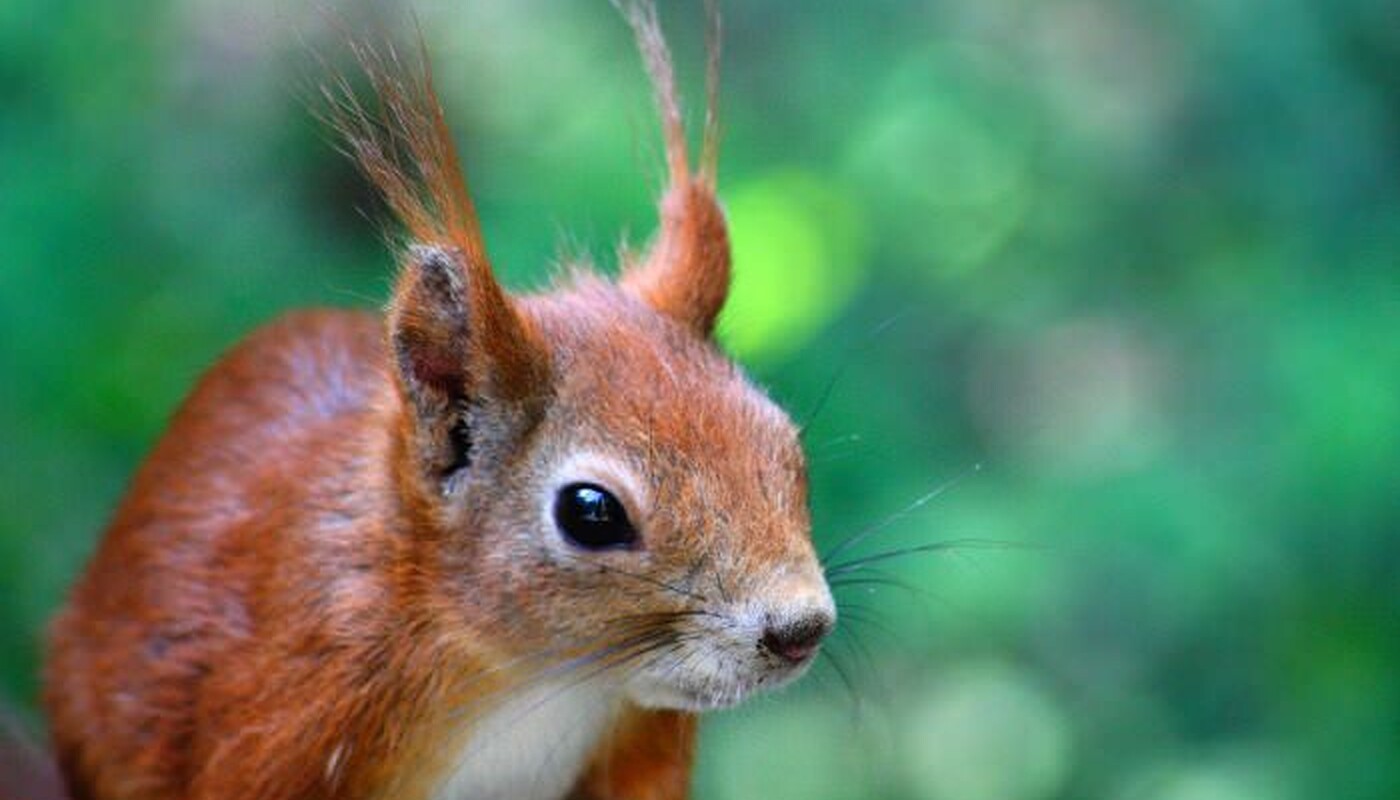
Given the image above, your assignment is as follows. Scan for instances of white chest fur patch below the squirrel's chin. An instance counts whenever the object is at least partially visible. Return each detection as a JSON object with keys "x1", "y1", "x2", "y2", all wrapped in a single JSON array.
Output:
[{"x1": 433, "y1": 678, "x2": 617, "y2": 800}]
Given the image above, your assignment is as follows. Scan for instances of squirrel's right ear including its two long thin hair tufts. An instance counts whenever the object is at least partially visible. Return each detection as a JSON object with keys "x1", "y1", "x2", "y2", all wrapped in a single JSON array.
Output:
[{"x1": 620, "y1": 0, "x2": 729, "y2": 336}]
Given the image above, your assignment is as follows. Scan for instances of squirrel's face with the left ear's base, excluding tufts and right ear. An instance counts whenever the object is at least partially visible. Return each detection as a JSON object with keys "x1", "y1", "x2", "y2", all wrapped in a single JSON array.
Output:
[{"x1": 391, "y1": 242, "x2": 834, "y2": 710}]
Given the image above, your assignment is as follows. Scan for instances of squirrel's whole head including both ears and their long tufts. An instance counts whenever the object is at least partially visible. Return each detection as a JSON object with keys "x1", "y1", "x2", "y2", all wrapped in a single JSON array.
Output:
[{"x1": 333, "y1": 3, "x2": 836, "y2": 710}]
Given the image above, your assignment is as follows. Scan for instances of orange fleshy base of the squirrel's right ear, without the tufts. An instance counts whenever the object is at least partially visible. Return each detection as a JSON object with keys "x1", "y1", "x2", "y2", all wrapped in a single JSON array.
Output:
[{"x1": 622, "y1": 177, "x2": 729, "y2": 336}]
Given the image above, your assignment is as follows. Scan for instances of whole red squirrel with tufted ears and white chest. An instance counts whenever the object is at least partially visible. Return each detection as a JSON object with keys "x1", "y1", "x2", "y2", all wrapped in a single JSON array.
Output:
[{"x1": 45, "y1": 0, "x2": 836, "y2": 800}]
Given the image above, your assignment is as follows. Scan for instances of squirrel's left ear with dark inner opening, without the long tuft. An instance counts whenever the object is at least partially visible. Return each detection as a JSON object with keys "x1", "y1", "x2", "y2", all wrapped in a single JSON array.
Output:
[{"x1": 388, "y1": 245, "x2": 549, "y2": 479}]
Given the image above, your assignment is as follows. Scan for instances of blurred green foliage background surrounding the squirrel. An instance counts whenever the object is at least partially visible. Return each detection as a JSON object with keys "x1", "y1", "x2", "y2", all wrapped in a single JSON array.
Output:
[{"x1": 0, "y1": 0, "x2": 1400, "y2": 800}]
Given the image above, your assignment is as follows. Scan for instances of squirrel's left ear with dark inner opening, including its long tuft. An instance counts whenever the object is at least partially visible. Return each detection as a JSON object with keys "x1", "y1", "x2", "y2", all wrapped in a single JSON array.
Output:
[{"x1": 322, "y1": 39, "x2": 552, "y2": 489}]
